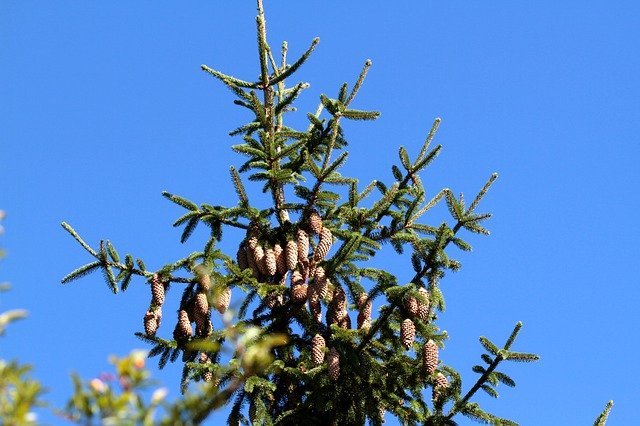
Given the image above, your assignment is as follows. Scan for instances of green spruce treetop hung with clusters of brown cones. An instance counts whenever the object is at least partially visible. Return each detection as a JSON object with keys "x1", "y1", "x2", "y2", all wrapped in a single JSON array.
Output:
[{"x1": 62, "y1": 0, "x2": 538, "y2": 425}]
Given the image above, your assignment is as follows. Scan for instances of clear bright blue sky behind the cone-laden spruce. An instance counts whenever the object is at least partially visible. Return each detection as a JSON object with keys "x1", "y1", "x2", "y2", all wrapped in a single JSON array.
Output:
[{"x1": 0, "y1": 0, "x2": 640, "y2": 425}]
